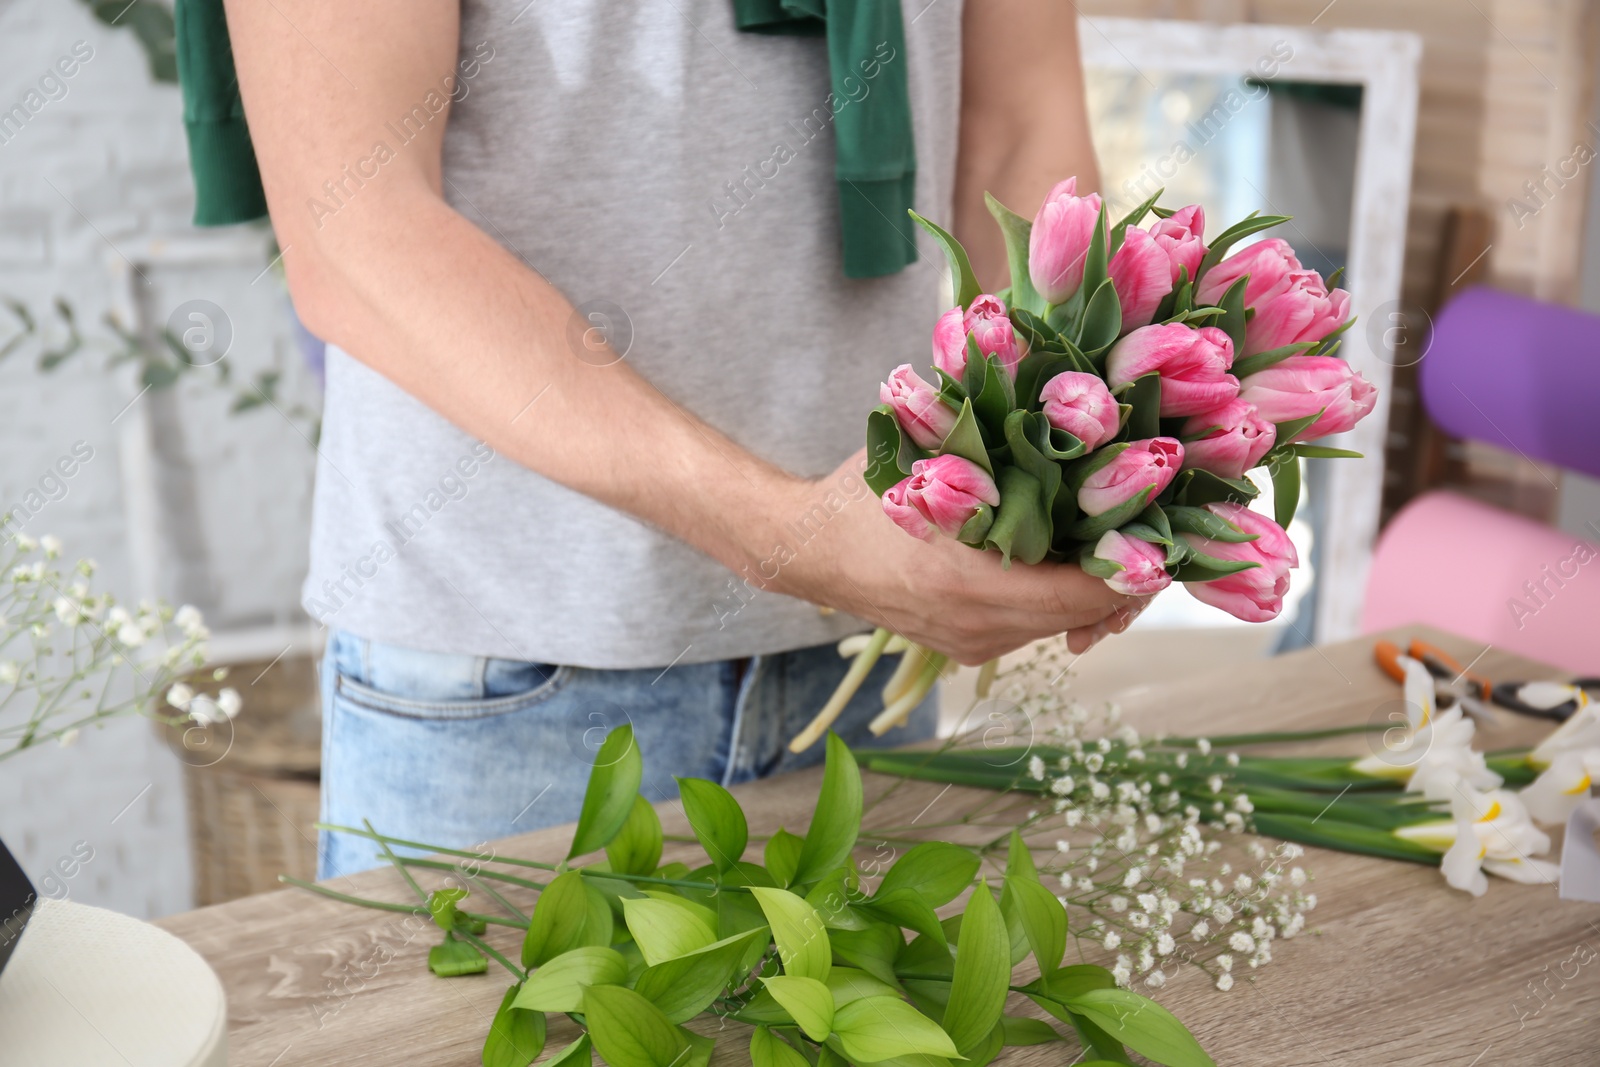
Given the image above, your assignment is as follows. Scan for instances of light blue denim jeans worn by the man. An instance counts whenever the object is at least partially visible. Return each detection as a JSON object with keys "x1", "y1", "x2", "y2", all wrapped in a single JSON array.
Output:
[{"x1": 317, "y1": 630, "x2": 938, "y2": 878}]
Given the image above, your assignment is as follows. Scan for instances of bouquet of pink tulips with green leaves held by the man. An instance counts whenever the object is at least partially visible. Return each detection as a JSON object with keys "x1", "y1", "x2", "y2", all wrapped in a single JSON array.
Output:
[{"x1": 792, "y1": 178, "x2": 1376, "y2": 750}]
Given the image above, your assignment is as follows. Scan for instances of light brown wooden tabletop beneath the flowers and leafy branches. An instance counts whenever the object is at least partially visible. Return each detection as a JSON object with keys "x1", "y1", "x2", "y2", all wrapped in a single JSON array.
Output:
[{"x1": 160, "y1": 627, "x2": 1600, "y2": 1067}]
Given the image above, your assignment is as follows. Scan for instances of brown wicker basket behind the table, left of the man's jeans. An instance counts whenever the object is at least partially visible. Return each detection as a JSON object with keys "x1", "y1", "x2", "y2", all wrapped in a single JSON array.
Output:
[{"x1": 162, "y1": 656, "x2": 322, "y2": 907}]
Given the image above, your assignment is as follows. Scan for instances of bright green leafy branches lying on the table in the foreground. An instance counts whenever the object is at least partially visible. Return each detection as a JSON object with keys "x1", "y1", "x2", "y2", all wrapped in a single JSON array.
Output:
[{"x1": 288, "y1": 726, "x2": 1213, "y2": 1067}]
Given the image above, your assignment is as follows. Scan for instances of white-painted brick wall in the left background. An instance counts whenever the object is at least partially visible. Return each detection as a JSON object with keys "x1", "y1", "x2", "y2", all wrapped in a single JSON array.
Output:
[{"x1": 0, "y1": 0, "x2": 310, "y2": 917}]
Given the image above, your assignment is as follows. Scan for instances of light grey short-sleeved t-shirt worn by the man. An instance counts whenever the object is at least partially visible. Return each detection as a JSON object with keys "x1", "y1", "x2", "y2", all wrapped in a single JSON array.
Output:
[{"x1": 304, "y1": 0, "x2": 962, "y2": 667}]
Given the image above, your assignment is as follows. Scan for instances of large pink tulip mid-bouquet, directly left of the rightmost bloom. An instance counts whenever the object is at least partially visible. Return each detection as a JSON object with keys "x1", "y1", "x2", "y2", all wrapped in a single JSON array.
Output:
[{"x1": 1106, "y1": 323, "x2": 1238, "y2": 418}]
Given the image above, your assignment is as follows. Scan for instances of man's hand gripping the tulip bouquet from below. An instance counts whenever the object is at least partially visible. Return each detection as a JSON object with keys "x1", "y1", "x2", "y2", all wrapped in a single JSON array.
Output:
[{"x1": 771, "y1": 451, "x2": 1146, "y2": 665}]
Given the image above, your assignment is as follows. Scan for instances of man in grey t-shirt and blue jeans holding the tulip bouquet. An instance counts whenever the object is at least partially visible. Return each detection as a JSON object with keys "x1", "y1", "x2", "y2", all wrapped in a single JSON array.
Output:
[{"x1": 227, "y1": 0, "x2": 1128, "y2": 877}]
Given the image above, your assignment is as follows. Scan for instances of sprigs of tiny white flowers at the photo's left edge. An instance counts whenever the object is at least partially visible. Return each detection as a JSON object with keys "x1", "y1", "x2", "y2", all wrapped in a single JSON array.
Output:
[{"x1": 0, "y1": 533, "x2": 242, "y2": 760}]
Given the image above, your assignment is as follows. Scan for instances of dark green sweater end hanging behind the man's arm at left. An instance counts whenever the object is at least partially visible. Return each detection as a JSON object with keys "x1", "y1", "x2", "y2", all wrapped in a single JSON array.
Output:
[{"x1": 173, "y1": 0, "x2": 267, "y2": 226}]
